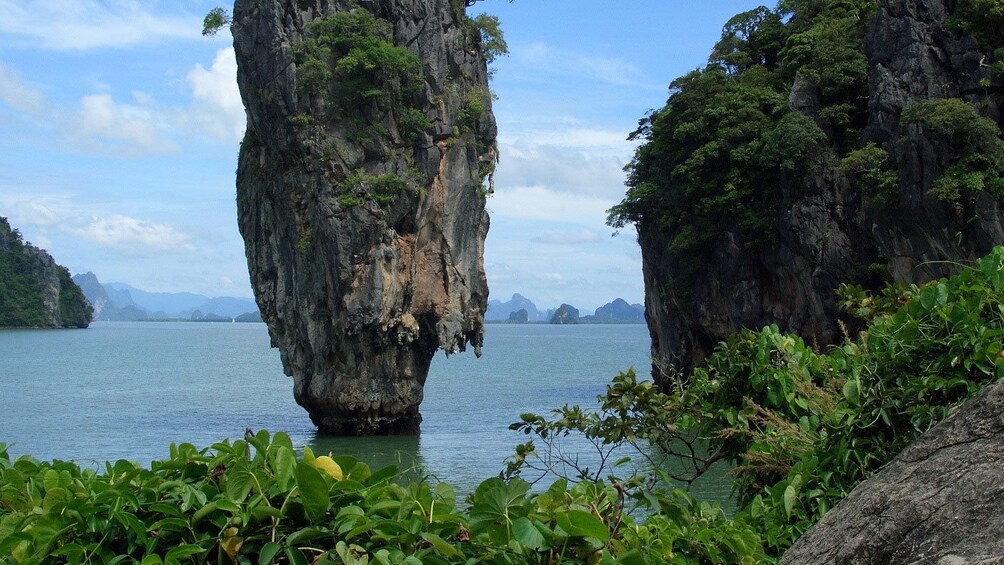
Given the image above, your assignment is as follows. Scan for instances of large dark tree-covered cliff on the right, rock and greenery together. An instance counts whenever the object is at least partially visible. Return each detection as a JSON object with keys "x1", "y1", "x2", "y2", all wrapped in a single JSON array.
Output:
[{"x1": 610, "y1": 0, "x2": 1004, "y2": 384}]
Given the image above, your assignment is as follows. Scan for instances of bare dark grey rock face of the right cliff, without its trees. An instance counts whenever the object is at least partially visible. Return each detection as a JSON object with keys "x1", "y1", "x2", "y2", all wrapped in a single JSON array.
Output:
[{"x1": 638, "y1": 0, "x2": 1004, "y2": 382}]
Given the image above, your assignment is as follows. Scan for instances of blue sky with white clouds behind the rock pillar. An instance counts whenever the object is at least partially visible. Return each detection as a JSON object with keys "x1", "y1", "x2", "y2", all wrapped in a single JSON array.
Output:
[{"x1": 0, "y1": 0, "x2": 759, "y2": 314}]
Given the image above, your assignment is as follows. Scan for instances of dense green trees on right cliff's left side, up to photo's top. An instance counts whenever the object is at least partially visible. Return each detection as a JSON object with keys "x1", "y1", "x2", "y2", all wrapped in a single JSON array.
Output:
[{"x1": 607, "y1": 0, "x2": 875, "y2": 296}]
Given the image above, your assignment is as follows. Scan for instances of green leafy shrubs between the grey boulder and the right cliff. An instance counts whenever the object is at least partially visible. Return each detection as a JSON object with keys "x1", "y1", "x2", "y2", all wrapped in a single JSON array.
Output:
[{"x1": 509, "y1": 247, "x2": 1004, "y2": 557}]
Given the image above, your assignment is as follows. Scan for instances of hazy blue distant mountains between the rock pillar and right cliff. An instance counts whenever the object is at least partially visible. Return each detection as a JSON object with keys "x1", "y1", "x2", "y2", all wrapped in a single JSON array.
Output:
[{"x1": 485, "y1": 293, "x2": 645, "y2": 324}]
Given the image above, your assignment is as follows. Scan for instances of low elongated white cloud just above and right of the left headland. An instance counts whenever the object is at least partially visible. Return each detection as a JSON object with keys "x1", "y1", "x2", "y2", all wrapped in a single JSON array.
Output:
[{"x1": 66, "y1": 214, "x2": 195, "y2": 254}]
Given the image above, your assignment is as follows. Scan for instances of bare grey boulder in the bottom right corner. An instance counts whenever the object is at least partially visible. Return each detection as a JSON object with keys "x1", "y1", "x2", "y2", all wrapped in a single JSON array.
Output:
[{"x1": 781, "y1": 375, "x2": 1004, "y2": 565}]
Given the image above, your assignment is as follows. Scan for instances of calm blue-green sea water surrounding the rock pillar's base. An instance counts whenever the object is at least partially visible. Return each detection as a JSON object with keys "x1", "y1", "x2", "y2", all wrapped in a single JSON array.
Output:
[{"x1": 0, "y1": 322, "x2": 728, "y2": 501}]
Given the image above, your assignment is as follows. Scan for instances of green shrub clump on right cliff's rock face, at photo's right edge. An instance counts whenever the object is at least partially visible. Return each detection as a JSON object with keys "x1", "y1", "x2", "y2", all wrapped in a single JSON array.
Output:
[{"x1": 902, "y1": 98, "x2": 1004, "y2": 213}]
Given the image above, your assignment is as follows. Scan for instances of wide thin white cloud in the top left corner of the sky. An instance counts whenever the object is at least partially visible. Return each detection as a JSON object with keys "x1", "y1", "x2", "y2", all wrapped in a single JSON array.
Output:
[{"x1": 0, "y1": 0, "x2": 202, "y2": 50}]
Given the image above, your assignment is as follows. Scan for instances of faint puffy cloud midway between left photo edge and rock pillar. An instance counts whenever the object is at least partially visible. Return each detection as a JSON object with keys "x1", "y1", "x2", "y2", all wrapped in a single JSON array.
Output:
[{"x1": 64, "y1": 92, "x2": 176, "y2": 155}]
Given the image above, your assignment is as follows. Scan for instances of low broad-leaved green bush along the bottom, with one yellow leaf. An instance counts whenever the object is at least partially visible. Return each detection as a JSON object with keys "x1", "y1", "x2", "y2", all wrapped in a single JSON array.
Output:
[{"x1": 0, "y1": 432, "x2": 758, "y2": 565}]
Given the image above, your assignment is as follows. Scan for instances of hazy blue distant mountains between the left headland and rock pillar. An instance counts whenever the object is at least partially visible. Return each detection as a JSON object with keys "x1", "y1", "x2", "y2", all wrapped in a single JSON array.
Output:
[{"x1": 73, "y1": 273, "x2": 261, "y2": 321}]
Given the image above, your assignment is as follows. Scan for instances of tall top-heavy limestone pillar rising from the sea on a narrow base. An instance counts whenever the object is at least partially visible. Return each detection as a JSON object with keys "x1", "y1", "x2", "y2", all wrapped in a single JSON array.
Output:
[{"x1": 232, "y1": 0, "x2": 495, "y2": 435}]
